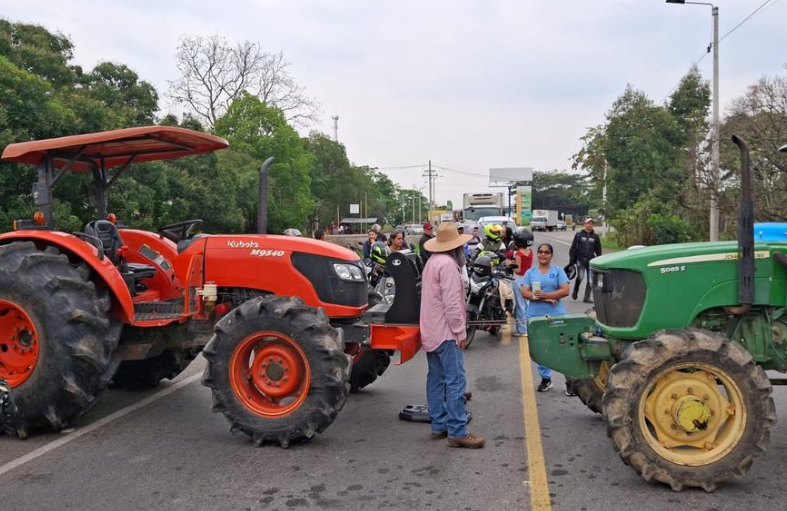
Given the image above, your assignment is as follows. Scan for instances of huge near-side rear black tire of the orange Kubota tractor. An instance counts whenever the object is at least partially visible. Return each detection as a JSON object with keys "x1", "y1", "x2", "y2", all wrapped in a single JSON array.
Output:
[{"x1": 0, "y1": 242, "x2": 122, "y2": 438}]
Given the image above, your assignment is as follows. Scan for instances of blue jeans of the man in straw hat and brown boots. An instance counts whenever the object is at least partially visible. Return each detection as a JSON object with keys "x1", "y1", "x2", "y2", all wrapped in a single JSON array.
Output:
[{"x1": 426, "y1": 340, "x2": 467, "y2": 438}]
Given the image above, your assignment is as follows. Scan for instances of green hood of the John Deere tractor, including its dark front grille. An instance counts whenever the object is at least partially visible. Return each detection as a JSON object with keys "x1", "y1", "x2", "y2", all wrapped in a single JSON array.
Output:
[{"x1": 590, "y1": 242, "x2": 787, "y2": 340}]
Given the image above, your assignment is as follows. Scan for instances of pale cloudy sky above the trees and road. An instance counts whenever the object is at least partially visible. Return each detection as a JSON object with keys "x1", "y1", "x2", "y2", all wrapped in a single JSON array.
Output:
[{"x1": 0, "y1": 0, "x2": 787, "y2": 204}]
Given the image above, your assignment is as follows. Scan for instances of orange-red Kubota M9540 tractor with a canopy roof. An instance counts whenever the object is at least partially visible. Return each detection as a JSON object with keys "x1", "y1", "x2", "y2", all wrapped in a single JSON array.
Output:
[{"x1": 0, "y1": 126, "x2": 420, "y2": 447}]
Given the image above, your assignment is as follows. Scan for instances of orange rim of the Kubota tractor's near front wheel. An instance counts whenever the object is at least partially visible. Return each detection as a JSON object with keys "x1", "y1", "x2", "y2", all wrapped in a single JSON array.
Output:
[{"x1": 229, "y1": 332, "x2": 311, "y2": 417}]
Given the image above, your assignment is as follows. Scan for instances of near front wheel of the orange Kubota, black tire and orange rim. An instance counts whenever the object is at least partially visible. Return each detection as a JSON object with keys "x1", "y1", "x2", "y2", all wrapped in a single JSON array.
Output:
[{"x1": 202, "y1": 296, "x2": 350, "y2": 447}]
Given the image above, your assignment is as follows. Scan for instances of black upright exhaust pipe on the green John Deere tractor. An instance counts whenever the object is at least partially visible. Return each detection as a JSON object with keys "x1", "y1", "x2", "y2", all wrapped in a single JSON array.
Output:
[{"x1": 727, "y1": 135, "x2": 754, "y2": 316}]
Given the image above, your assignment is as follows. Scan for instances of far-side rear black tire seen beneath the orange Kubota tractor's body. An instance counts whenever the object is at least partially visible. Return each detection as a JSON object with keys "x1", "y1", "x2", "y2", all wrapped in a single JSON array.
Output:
[{"x1": 112, "y1": 349, "x2": 199, "y2": 390}]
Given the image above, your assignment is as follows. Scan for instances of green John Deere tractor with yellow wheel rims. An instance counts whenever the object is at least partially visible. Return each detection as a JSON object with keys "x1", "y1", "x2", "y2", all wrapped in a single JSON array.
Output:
[{"x1": 528, "y1": 137, "x2": 787, "y2": 492}]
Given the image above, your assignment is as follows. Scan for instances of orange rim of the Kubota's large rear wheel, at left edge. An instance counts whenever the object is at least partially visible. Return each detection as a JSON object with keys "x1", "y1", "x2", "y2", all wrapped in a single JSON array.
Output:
[{"x1": 0, "y1": 300, "x2": 40, "y2": 387}]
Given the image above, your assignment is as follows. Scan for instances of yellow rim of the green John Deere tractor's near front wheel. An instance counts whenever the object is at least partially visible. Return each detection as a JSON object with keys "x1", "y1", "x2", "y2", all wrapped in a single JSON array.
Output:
[{"x1": 638, "y1": 362, "x2": 747, "y2": 467}]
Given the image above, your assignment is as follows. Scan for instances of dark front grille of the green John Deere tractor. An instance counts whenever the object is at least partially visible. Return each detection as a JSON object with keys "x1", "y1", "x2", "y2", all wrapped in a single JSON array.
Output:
[{"x1": 593, "y1": 270, "x2": 646, "y2": 328}]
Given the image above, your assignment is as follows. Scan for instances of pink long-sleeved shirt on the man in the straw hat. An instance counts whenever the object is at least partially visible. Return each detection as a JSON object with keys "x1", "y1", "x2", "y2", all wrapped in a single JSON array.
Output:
[{"x1": 421, "y1": 252, "x2": 467, "y2": 351}]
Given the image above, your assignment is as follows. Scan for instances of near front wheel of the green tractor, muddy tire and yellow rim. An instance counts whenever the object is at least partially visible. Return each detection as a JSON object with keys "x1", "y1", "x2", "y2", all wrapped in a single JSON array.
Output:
[{"x1": 604, "y1": 328, "x2": 776, "y2": 492}]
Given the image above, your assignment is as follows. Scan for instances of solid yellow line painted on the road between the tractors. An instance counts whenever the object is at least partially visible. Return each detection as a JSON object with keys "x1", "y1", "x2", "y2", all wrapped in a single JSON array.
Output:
[{"x1": 519, "y1": 337, "x2": 552, "y2": 511}]
